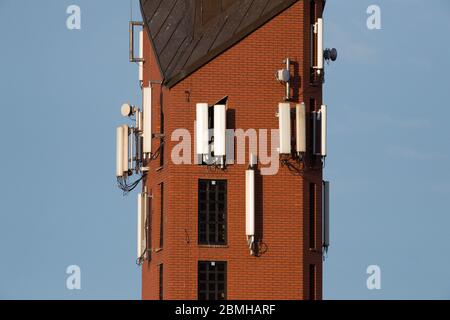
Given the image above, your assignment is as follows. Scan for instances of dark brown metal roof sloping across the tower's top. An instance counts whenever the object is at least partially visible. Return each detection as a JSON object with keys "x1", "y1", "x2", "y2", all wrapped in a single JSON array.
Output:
[{"x1": 140, "y1": 0, "x2": 298, "y2": 87}]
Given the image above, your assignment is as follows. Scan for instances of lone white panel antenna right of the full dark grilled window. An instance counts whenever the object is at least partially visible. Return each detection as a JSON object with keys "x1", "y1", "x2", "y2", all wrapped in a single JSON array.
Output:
[{"x1": 245, "y1": 170, "x2": 255, "y2": 254}]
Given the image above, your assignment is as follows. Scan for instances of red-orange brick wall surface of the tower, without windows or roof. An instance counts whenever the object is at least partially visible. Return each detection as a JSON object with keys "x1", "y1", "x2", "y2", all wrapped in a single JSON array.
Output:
[{"x1": 142, "y1": 1, "x2": 322, "y2": 299}]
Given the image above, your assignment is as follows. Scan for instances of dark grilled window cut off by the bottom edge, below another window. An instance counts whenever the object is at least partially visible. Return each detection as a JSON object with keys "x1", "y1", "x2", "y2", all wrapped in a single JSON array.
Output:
[{"x1": 198, "y1": 261, "x2": 227, "y2": 300}]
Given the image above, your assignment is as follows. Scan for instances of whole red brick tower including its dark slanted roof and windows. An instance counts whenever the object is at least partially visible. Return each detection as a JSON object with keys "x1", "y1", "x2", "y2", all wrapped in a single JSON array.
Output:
[{"x1": 137, "y1": 0, "x2": 325, "y2": 300}]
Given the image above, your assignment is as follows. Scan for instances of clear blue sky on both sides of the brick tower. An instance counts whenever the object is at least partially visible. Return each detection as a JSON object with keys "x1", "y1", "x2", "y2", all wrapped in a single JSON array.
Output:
[{"x1": 0, "y1": 0, "x2": 450, "y2": 299}]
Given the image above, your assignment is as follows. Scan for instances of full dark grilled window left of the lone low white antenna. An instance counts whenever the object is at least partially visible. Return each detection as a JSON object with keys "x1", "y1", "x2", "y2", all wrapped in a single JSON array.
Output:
[{"x1": 198, "y1": 180, "x2": 227, "y2": 245}]
